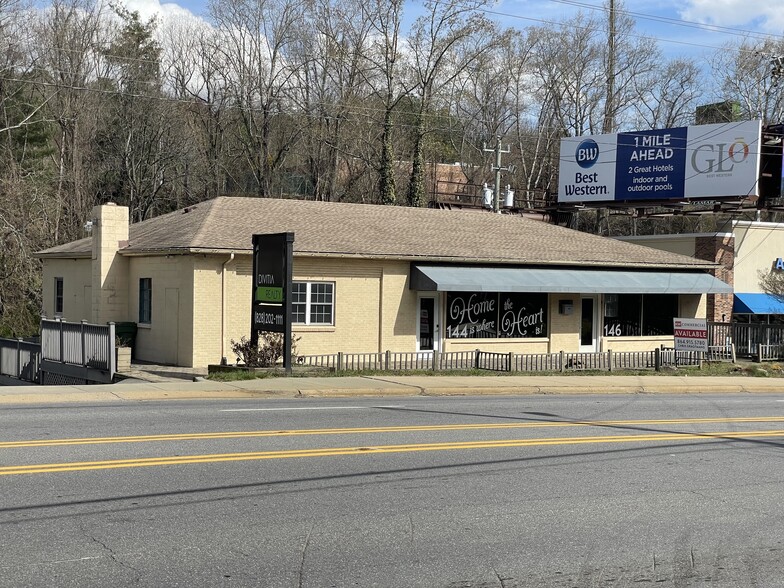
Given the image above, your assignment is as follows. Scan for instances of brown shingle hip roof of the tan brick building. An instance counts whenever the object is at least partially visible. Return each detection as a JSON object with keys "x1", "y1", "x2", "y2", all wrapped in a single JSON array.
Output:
[{"x1": 39, "y1": 197, "x2": 712, "y2": 269}]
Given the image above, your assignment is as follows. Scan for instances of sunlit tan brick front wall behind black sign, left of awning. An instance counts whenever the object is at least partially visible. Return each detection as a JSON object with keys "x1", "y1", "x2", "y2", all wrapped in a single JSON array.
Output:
[{"x1": 208, "y1": 256, "x2": 417, "y2": 365}]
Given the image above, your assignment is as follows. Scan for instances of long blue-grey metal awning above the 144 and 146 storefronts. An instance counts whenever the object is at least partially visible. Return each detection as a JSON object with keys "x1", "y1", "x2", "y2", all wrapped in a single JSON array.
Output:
[{"x1": 410, "y1": 265, "x2": 732, "y2": 294}]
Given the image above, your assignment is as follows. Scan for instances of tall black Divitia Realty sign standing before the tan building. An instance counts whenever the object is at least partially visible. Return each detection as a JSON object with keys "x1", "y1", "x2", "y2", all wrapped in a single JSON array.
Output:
[{"x1": 250, "y1": 233, "x2": 294, "y2": 375}]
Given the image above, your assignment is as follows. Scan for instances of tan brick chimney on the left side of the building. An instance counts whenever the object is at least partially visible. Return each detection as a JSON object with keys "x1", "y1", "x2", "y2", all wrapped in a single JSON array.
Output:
[{"x1": 91, "y1": 202, "x2": 130, "y2": 324}]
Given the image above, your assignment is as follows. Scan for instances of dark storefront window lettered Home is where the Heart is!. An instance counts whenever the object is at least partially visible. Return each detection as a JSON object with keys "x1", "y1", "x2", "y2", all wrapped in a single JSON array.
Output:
[{"x1": 446, "y1": 292, "x2": 547, "y2": 339}]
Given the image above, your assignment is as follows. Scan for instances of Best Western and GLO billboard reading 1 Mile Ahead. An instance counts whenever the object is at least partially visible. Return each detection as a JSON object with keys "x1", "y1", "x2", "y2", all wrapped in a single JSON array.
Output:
[{"x1": 558, "y1": 120, "x2": 762, "y2": 203}]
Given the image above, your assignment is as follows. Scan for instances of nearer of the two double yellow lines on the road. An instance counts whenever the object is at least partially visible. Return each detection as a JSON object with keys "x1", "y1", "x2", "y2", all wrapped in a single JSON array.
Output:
[{"x1": 0, "y1": 430, "x2": 784, "y2": 476}]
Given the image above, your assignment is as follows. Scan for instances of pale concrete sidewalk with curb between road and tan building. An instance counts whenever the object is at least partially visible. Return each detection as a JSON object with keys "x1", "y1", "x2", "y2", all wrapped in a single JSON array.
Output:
[{"x1": 0, "y1": 375, "x2": 784, "y2": 405}]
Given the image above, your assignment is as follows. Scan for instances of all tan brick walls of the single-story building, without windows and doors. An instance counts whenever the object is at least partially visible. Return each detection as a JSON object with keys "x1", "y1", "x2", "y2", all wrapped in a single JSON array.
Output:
[{"x1": 44, "y1": 249, "x2": 706, "y2": 366}]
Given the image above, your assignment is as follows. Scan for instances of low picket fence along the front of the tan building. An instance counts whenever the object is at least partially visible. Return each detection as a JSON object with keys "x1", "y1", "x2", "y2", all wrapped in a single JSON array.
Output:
[{"x1": 296, "y1": 347, "x2": 735, "y2": 373}]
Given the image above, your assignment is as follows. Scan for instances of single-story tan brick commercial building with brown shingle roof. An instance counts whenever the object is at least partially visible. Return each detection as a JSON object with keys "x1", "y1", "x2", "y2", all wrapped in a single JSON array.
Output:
[{"x1": 38, "y1": 197, "x2": 732, "y2": 366}]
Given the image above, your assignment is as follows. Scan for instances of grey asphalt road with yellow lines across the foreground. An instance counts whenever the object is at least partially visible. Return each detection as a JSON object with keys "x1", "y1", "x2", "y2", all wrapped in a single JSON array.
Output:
[{"x1": 0, "y1": 394, "x2": 784, "y2": 588}]
